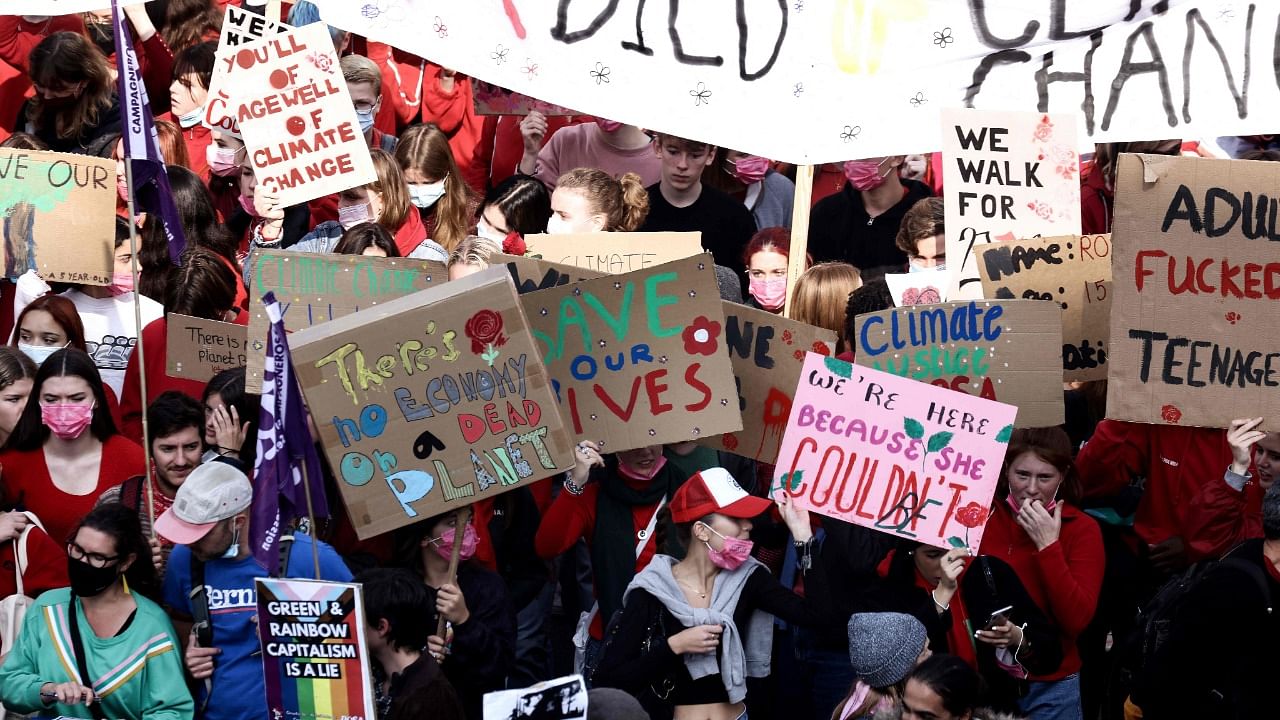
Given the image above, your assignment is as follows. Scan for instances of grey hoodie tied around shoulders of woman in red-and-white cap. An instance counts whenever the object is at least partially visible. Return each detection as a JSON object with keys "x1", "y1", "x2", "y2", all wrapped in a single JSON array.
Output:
[{"x1": 622, "y1": 555, "x2": 773, "y2": 702}]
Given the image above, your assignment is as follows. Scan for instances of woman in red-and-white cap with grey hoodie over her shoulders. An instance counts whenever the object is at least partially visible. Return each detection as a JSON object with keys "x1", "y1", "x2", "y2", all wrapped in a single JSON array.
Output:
[{"x1": 593, "y1": 468, "x2": 831, "y2": 720}]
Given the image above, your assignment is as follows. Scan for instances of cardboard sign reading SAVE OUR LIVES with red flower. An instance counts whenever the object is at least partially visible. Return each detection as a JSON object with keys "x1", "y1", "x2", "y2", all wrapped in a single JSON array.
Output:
[{"x1": 520, "y1": 254, "x2": 742, "y2": 452}]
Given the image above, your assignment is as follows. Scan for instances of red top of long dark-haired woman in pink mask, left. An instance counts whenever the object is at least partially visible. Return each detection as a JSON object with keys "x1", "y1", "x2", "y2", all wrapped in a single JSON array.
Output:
[{"x1": 0, "y1": 430, "x2": 143, "y2": 542}]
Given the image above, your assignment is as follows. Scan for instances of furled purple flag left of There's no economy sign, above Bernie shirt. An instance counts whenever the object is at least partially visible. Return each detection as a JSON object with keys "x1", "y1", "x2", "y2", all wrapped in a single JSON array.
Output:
[{"x1": 248, "y1": 292, "x2": 329, "y2": 571}]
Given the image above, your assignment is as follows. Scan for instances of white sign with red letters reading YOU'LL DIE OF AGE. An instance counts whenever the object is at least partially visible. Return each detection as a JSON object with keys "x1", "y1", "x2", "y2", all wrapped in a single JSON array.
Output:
[{"x1": 218, "y1": 23, "x2": 378, "y2": 206}]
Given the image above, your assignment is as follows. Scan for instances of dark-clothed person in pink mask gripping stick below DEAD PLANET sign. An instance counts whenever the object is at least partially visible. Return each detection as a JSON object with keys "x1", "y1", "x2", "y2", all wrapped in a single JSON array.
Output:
[{"x1": 397, "y1": 511, "x2": 516, "y2": 720}]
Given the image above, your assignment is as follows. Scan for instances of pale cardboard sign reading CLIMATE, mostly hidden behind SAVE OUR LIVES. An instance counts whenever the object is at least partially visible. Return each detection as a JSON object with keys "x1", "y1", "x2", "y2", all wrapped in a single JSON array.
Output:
[{"x1": 525, "y1": 232, "x2": 703, "y2": 274}]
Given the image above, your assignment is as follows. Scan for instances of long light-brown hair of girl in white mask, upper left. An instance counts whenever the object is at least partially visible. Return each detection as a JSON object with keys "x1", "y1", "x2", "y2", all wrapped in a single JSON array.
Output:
[{"x1": 396, "y1": 123, "x2": 479, "y2": 251}]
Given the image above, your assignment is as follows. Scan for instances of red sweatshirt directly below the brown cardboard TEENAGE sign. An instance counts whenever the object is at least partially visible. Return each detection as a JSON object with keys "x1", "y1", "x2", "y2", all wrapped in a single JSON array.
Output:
[{"x1": 1075, "y1": 420, "x2": 1231, "y2": 562}]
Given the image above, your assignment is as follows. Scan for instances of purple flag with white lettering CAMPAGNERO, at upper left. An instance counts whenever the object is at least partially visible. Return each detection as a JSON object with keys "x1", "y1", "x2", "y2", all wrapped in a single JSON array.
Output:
[{"x1": 111, "y1": 0, "x2": 187, "y2": 265}]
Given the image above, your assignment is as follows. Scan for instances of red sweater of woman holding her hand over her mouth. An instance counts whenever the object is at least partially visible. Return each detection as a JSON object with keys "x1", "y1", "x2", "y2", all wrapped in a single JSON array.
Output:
[{"x1": 978, "y1": 502, "x2": 1106, "y2": 680}]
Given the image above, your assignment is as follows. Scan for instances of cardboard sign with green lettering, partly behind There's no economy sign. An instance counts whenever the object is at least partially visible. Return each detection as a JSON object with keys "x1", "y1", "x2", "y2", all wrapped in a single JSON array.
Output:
[{"x1": 244, "y1": 250, "x2": 449, "y2": 392}]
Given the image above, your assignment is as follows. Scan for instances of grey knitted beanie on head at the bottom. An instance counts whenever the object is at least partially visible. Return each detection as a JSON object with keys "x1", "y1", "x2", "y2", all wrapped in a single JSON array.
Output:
[{"x1": 849, "y1": 612, "x2": 929, "y2": 688}]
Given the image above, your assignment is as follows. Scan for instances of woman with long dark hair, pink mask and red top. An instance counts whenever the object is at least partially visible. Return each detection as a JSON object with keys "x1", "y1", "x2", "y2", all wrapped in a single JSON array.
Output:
[{"x1": 0, "y1": 347, "x2": 143, "y2": 538}]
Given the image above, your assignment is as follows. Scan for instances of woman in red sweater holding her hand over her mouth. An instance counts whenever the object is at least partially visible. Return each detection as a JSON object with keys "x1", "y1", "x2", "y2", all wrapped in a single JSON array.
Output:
[{"x1": 977, "y1": 428, "x2": 1105, "y2": 720}]
